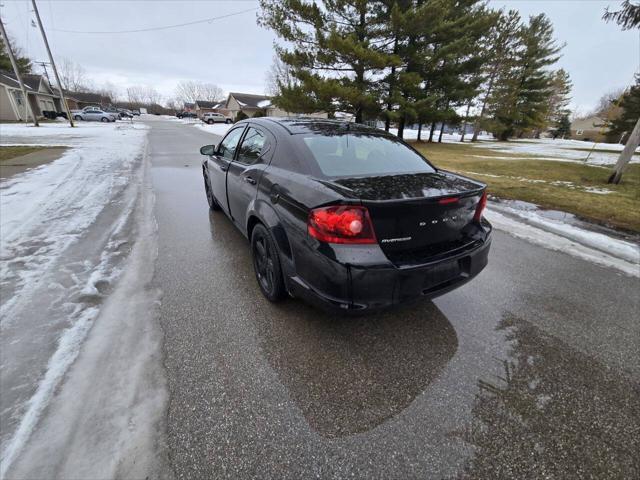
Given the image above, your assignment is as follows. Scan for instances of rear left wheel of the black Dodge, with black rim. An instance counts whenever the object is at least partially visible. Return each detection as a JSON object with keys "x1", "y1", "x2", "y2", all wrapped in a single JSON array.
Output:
[{"x1": 251, "y1": 223, "x2": 287, "y2": 303}]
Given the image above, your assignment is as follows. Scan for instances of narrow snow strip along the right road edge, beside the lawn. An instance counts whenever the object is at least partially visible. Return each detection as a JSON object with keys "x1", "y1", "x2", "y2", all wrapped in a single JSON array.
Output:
[{"x1": 485, "y1": 202, "x2": 640, "y2": 277}]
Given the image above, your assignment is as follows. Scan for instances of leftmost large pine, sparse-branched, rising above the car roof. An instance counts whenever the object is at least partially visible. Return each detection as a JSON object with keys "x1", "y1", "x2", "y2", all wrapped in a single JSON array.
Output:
[{"x1": 258, "y1": 0, "x2": 395, "y2": 122}]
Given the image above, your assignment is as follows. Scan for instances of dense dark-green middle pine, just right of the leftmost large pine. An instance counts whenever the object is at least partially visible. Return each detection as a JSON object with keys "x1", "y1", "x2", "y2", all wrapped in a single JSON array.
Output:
[{"x1": 396, "y1": 0, "x2": 495, "y2": 137}]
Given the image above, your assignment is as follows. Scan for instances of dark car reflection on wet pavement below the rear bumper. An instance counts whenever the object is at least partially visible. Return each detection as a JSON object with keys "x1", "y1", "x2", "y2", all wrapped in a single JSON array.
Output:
[{"x1": 255, "y1": 300, "x2": 458, "y2": 437}]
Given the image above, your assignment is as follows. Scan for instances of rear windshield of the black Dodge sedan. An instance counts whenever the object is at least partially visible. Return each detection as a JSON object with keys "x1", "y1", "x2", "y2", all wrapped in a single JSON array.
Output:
[{"x1": 302, "y1": 133, "x2": 435, "y2": 177}]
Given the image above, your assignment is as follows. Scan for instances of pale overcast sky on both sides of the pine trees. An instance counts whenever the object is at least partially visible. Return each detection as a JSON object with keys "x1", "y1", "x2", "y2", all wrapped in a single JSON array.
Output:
[{"x1": 0, "y1": 0, "x2": 640, "y2": 113}]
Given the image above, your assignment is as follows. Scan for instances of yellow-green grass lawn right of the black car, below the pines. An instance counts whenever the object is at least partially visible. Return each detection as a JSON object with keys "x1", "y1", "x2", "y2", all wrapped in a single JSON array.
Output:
[{"x1": 413, "y1": 143, "x2": 640, "y2": 232}]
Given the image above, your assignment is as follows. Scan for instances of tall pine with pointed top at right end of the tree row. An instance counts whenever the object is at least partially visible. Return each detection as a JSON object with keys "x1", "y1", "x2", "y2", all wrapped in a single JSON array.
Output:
[{"x1": 489, "y1": 14, "x2": 562, "y2": 140}]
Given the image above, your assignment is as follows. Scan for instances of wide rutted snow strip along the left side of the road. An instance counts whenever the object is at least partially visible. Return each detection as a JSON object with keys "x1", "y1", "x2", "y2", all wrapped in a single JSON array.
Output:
[{"x1": 0, "y1": 123, "x2": 164, "y2": 478}]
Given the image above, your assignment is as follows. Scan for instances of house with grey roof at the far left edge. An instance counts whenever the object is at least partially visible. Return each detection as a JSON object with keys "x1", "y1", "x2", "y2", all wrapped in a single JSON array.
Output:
[{"x1": 0, "y1": 70, "x2": 63, "y2": 121}]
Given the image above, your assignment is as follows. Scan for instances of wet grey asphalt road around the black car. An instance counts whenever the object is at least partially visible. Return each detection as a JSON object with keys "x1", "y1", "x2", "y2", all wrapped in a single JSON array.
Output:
[{"x1": 149, "y1": 120, "x2": 640, "y2": 479}]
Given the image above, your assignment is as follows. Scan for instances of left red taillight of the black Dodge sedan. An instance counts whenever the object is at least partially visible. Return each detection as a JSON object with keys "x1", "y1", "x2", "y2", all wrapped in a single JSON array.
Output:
[{"x1": 307, "y1": 205, "x2": 376, "y2": 244}]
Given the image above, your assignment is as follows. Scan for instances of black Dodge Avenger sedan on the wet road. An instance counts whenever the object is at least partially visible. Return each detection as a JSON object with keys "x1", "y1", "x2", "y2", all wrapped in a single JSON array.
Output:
[{"x1": 200, "y1": 118, "x2": 491, "y2": 312}]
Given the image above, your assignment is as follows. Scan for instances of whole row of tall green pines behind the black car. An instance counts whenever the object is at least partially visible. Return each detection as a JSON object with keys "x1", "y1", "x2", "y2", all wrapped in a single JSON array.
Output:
[{"x1": 258, "y1": 0, "x2": 571, "y2": 140}]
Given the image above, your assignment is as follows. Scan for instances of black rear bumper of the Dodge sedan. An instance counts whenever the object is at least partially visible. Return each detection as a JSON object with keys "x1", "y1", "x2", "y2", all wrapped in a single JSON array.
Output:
[{"x1": 287, "y1": 234, "x2": 491, "y2": 314}]
